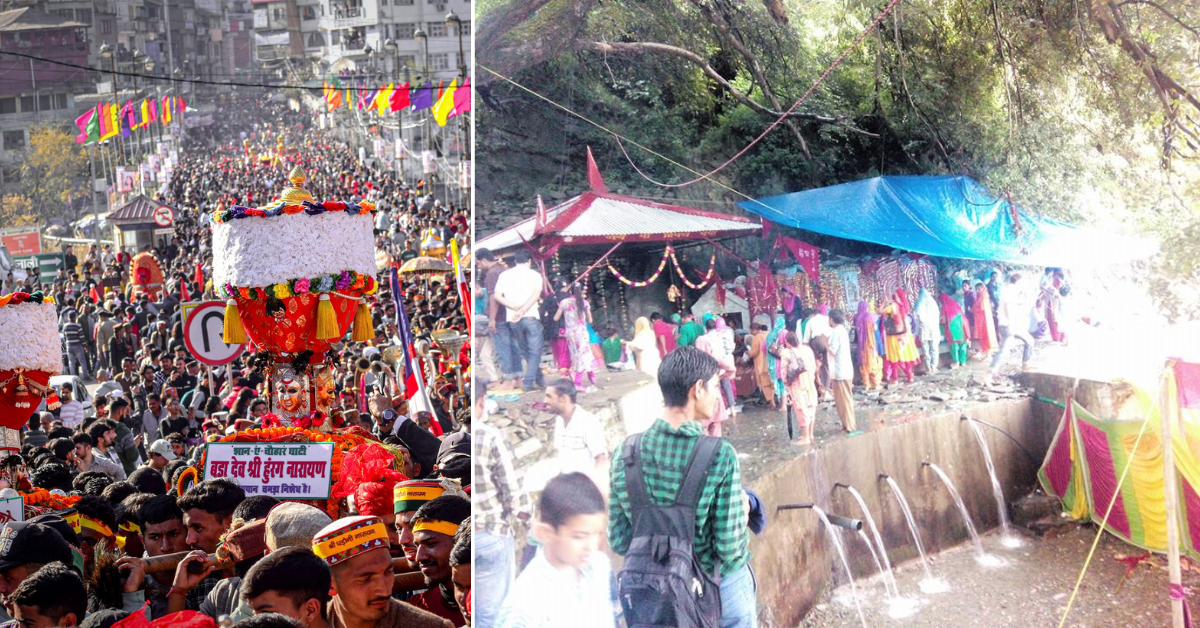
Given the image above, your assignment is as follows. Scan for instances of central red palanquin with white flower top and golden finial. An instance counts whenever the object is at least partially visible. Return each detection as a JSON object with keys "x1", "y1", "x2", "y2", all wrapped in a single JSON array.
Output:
[{"x1": 212, "y1": 167, "x2": 376, "y2": 432}]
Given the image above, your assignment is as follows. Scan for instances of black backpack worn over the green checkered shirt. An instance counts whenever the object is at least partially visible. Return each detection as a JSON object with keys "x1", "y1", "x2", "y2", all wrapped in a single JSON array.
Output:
[{"x1": 617, "y1": 433, "x2": 721, "y2": 628}]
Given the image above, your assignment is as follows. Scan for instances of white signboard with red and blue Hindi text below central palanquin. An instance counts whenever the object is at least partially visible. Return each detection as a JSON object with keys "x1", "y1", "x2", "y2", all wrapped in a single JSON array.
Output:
[{"x1": 204, "y1": 443, "x2": 334, "y2": 500}]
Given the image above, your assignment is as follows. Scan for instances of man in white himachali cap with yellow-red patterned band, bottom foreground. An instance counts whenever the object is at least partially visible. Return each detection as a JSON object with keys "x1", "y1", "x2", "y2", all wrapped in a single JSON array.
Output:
[{"x1": 312, "y1": 516, "x2": 454, "y2": 628}]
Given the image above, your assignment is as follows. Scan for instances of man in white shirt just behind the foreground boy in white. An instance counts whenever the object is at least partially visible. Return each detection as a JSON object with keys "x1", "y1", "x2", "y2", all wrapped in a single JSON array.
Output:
[{"x1": 546, "y1": 378, "x2": 608, "y2": 492}]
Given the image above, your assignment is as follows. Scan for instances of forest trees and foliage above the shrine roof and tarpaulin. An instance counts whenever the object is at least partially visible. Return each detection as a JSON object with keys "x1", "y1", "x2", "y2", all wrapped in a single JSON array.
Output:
[{"x1": 476, "y1": 0, "x2": 1200, "y2": 316}]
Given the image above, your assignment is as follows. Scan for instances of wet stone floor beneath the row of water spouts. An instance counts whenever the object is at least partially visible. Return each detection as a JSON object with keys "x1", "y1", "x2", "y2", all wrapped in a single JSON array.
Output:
[{"x1": 799, "y1": 526, "x2": 1200, "y2": 628}]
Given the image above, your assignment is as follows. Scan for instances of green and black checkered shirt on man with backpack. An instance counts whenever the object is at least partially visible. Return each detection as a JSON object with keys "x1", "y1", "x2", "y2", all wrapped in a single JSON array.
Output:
[{"x1": 608, "y1": 419, "x2": 750, "y2": 575}]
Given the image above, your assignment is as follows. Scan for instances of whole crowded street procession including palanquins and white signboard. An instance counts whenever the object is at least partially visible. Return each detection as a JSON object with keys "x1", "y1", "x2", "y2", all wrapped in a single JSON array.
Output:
[{"x1": 0, "y1": 97, "x2": 472, "y2": 628}]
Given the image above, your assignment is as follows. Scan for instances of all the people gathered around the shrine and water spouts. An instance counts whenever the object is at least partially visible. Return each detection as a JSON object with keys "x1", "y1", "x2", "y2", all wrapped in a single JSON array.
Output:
[{"x1": 475, "y1": 238, "x2": 1070, "y2": 628}]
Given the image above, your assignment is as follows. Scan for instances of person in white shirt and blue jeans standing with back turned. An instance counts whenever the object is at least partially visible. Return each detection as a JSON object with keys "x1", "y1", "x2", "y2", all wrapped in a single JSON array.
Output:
[{"x1": 496, "y1": 250, "x2": 545, "y2": 393}]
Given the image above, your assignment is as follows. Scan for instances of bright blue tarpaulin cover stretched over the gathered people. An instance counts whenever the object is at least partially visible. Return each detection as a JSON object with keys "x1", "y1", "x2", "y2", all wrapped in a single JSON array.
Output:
[{"x1": 739, "y1": 177, "x2": 1157, "y2": 268}]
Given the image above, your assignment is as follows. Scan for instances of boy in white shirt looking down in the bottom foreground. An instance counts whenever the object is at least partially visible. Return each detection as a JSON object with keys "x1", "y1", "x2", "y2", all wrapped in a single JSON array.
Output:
[{"x1": 499, "y1": 472, "x2": 617, "y2": 628}]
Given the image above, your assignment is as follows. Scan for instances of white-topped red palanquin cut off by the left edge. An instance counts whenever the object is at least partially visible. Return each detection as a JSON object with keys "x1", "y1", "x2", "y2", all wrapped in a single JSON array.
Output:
[{"x1": 0, "y1": 292, "x2": 62, "y2": 437}]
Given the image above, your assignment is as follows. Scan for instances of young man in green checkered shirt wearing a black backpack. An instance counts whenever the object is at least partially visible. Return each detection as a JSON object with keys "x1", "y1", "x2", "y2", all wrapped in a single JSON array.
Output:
[{"x1": 608, "y1": 347, "x2": 757, "y2": 628}]
